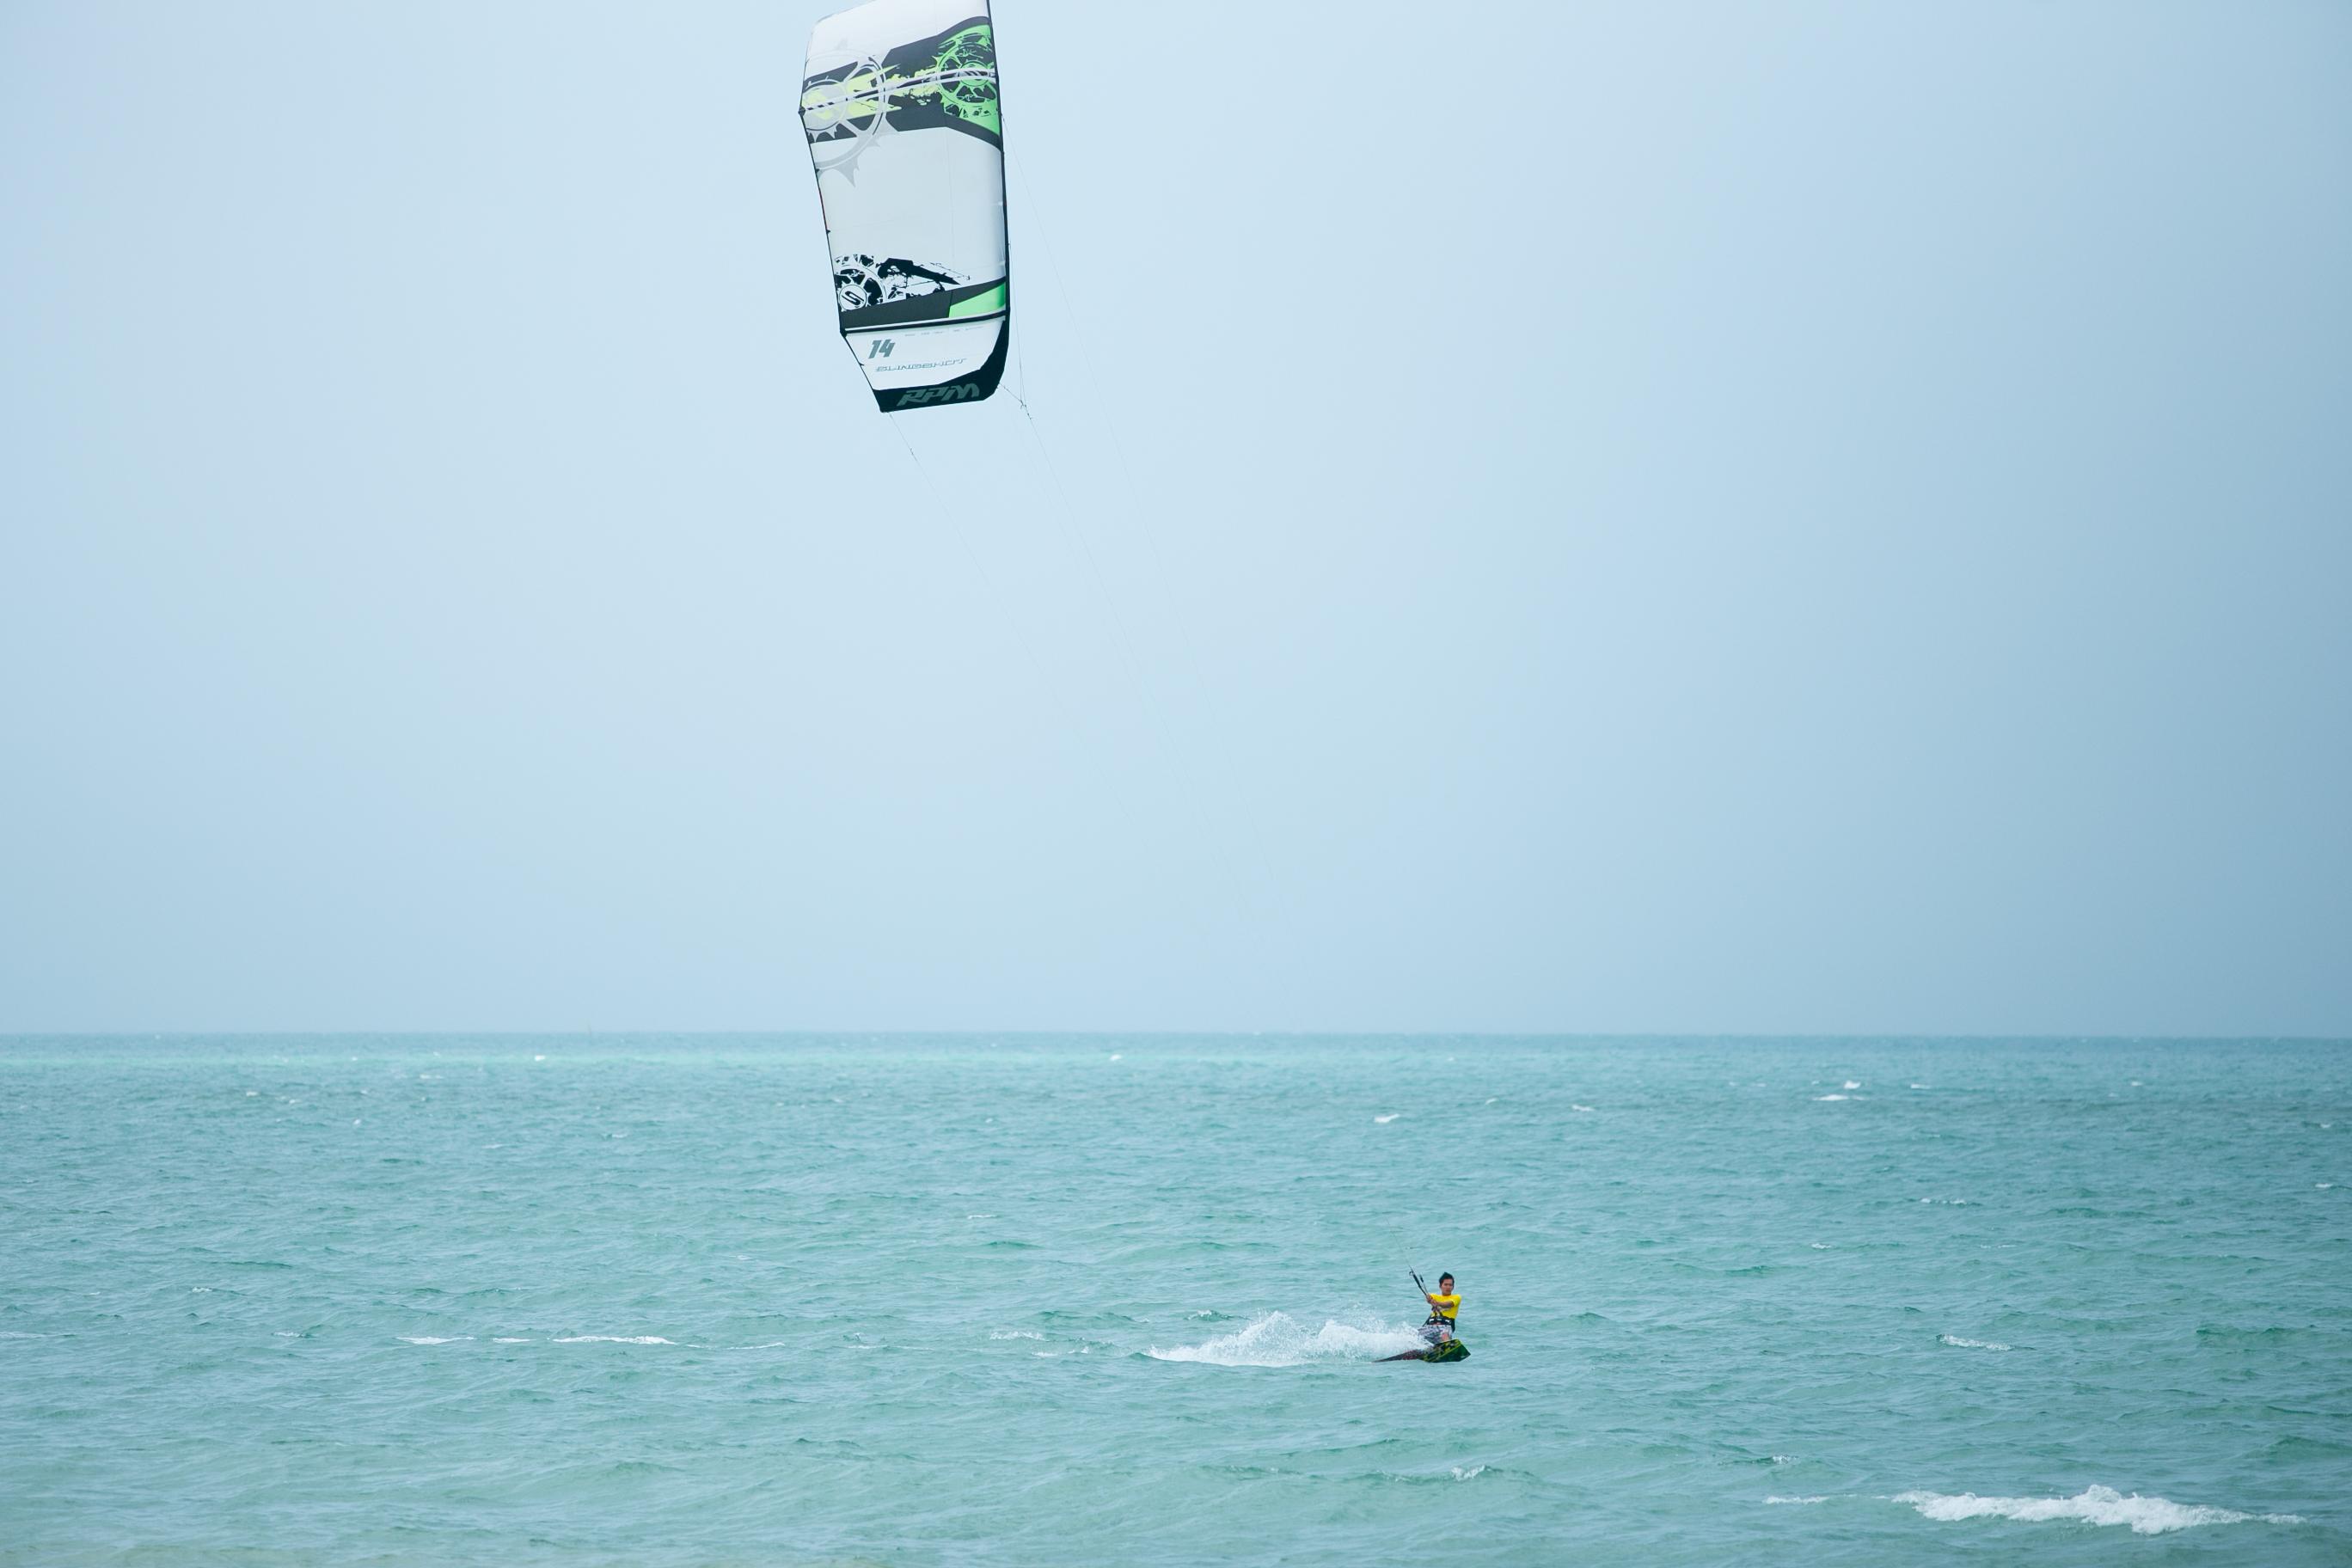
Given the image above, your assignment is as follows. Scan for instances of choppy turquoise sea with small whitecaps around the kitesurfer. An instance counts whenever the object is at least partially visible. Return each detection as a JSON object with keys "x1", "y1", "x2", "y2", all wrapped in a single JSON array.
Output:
[{"x1": 0, "y1": 1037, "x2": 2352, "y2": 1565}]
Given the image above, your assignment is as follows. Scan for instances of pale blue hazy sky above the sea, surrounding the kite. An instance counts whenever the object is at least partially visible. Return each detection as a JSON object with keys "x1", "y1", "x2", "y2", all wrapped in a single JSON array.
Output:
[{"x1": 0, "y1": 0, "x2": 2352, "y2": 1034}]
